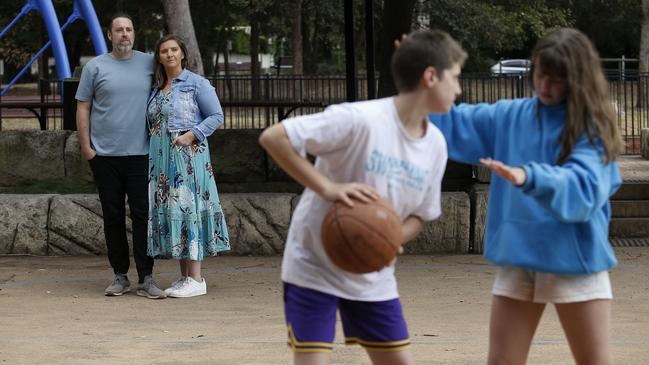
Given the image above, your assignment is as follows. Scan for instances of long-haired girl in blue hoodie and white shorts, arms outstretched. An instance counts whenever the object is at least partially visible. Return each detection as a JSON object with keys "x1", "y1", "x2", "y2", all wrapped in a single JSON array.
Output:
[{"x1": 431, "y1": 28, "x2": 623, "y2": 364}]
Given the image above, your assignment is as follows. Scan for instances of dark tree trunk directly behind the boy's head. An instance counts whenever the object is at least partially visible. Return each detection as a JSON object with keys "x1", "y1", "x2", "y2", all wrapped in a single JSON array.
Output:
[{"x1": 377, "y1": 0, "x2": 415, "y2": 97}]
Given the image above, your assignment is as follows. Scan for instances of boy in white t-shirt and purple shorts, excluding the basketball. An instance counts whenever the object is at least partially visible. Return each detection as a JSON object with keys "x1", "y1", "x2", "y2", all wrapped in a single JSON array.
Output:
[{"x1": 259, "y1": 31, "x2": 466, "y2": 364}]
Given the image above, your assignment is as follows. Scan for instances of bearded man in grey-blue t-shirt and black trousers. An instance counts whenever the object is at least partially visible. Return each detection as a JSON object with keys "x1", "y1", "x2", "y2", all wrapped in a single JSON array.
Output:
[{"x1": 76, "y1": 14, "x2": 165, "y2": 298}]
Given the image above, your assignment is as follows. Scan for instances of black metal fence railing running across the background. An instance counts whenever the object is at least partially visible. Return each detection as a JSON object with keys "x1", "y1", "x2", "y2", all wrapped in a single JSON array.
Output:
[{"x1": 0, "y1": 73, "x2": 649, "y2": 154}]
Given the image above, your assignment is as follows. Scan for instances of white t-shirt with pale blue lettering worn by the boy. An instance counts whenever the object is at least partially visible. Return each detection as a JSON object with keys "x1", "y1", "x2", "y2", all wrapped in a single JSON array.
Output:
[{"x1": 282, "y1": 98, "x2": 447, "y2": 301}]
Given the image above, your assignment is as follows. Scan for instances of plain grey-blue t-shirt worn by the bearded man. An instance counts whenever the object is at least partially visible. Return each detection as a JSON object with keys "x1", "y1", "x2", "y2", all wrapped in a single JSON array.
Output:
[{"x1": 76, "y1": 51, "x2": 153, "y2": 156}]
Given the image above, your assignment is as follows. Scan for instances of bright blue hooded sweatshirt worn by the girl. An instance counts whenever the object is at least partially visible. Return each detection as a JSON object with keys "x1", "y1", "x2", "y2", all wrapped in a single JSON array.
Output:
[{"x1": 430, "y1": 97, "x2": 622, "y2": 275}]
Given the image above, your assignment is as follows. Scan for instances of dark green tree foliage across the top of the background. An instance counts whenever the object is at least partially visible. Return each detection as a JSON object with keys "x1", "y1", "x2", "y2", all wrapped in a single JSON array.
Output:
[{"x1": 0, "y1": 0, "x2": 642, "y2": 74}]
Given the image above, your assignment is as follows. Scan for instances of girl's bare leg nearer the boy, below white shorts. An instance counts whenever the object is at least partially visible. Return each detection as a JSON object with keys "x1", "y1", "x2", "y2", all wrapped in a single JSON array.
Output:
[{"x1": 487, "y1": 295, "x2": 545, "y2": 365}]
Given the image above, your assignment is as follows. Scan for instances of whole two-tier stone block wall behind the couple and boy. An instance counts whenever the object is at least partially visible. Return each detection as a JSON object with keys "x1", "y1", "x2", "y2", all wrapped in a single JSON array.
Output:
[{"x1": 0, "y1": 130, "x2": 489, "y2": 255}]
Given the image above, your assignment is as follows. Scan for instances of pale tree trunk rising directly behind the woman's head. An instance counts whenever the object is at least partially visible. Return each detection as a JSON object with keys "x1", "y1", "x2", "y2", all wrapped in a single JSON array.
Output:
[{"x1": 160, "y1": 0, "x2": 204, "y2": 75}]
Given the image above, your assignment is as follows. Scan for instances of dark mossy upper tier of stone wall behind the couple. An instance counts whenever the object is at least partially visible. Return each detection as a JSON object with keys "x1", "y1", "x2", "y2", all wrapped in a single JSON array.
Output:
[{"x1": 0, "y1": 129, "x2": 291, "y2": 193}]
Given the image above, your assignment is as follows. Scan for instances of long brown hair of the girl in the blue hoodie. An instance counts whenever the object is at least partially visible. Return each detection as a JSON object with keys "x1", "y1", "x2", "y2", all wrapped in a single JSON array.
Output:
[{"x1": 530, "y1": 28, "x2": 624, "y2": 165}]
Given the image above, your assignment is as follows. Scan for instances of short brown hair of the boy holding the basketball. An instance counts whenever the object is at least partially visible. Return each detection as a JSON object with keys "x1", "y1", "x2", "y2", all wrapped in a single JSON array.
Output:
[{"x1": 391, "y1": 30, "x2": 467, "y2": 92}]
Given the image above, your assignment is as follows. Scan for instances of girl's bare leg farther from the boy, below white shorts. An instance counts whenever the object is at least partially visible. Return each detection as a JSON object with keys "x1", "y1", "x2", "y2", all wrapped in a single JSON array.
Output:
[{"x1": 556, "y1": 300, "x2": 613, "y2": 364}]
